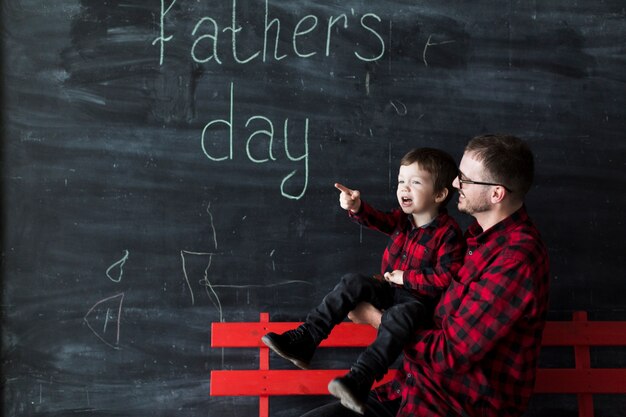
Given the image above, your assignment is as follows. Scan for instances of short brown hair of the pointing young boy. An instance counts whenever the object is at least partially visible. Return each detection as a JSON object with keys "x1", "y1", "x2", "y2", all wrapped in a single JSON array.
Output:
[{"x1": 400, "y1": 148, "x2": 459, "y2": 207}]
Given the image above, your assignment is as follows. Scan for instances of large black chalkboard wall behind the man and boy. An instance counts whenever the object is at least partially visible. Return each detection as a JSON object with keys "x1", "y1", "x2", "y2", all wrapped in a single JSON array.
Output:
[{"x1": 2, "y1": 0, "x2": 626, "y2": 417}]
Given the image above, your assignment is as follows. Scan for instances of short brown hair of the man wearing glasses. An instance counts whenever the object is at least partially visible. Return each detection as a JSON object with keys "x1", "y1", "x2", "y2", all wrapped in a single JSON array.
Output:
[{"x1": 465, "y1": 134, "x2": 535, "y2": 199}]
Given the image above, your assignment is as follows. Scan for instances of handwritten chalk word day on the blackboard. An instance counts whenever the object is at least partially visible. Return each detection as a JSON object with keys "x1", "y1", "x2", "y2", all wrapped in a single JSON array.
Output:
[{"x1": 201, "y1": 82, "x2": 309, "y2": 200}]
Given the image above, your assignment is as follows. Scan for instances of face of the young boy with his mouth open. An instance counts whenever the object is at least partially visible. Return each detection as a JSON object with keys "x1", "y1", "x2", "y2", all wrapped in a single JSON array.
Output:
[{"x1": 396, "y1": 162, "x2": 438, "y2": 214}]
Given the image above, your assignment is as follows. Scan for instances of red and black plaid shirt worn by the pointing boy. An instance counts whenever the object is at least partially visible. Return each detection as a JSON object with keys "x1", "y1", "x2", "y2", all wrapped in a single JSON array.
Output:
[{"x1": 350, "y1": 202, "x2": 465, "y2": 298}]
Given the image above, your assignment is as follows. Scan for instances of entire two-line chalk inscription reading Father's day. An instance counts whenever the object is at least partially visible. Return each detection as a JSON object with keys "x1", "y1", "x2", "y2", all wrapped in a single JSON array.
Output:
[{"x1": 152, "y1": 0, "x2": 385, "y2": 200}]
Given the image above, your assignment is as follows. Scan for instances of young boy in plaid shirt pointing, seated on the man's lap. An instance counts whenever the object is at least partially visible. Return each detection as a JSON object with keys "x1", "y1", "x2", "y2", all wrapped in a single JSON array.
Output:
[{"x1": 262, "y1": 148, "x2": 464, "y2": 414}]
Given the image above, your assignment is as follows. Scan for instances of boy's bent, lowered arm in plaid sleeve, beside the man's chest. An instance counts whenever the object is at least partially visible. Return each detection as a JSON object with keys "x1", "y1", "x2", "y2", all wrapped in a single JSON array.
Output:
[{"x1": 402, "y1": 228, "x2": 465, "y2": 297}]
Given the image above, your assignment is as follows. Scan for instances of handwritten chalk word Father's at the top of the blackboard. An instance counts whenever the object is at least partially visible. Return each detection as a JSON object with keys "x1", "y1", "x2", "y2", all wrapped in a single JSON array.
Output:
[{"x1": 152, "y1": 0, "x2": 385, "y2": 65}]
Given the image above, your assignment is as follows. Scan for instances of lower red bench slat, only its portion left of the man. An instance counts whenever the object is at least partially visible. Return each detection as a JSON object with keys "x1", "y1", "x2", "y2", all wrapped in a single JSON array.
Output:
[{"x1": 211, "y1": 369, "x2": 395, "y2": 396}]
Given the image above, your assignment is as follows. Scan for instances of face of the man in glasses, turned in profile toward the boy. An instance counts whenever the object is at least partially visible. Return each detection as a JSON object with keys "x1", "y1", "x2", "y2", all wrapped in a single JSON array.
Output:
[{"x1": 452, "y1": 152, "x2": 492, "y2": 216}]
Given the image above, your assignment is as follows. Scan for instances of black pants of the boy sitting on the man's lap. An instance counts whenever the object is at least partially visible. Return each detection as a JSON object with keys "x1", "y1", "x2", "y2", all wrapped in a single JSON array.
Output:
[{"x1": 305, "y1": 274, "x2": 432, "y2": 379}]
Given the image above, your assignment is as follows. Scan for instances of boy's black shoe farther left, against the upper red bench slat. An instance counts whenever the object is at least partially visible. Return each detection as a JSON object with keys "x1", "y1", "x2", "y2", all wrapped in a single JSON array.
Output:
[{"x1": 261, "y1": 326, "x2": 317, "y2": 369}]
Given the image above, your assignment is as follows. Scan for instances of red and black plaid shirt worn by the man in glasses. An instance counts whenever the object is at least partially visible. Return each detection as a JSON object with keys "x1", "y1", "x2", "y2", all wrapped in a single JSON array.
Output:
[{"x1": 377, "y1": 207, "x2": 549, "y2": 417}]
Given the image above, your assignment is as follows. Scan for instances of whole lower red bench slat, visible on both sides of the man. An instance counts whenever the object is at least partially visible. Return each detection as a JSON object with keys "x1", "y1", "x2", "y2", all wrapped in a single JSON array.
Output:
[{"x1": 211, "y1": 368, "x2": 626, "y2": 396}]
